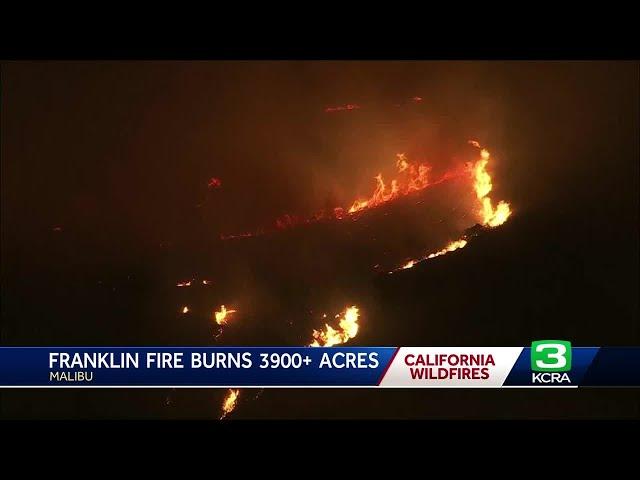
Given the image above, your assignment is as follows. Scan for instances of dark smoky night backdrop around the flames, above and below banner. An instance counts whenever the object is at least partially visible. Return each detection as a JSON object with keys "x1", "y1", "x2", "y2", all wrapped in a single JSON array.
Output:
[{"x1": 0, "y1": 61, "x2": 640, "y2": 418}]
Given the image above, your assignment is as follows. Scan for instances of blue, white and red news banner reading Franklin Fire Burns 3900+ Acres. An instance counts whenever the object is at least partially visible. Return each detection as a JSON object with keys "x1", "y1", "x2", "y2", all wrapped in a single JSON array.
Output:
[{"x1": 0, "y1": 340, "x2": 640, "y2": 388}]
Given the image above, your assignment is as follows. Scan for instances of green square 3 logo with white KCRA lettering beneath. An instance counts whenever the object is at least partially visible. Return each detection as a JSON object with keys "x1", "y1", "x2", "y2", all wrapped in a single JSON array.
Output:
[{"x1": 531, "y1": 340, "x2": 571, "y2": 384}]
